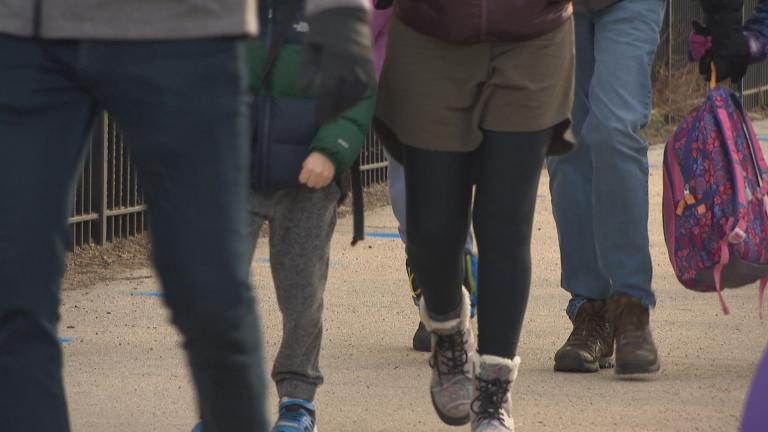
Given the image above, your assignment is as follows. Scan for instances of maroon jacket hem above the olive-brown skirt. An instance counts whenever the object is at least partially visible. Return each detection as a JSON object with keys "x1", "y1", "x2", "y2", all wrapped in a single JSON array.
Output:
[{"x1": 395, "y1": 0, "x2": 573, "y2": 44}]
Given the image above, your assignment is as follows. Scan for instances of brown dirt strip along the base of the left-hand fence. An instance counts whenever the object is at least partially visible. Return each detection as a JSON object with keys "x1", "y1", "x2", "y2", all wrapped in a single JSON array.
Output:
[{"x1": 62, "y1": 183, "x2": 389, "y2": 290}]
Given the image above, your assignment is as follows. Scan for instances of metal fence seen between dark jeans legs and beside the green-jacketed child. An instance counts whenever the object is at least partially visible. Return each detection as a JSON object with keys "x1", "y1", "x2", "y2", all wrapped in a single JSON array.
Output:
[{"x1": 69, "y1": 113, "x2": 387, "y2": 247}]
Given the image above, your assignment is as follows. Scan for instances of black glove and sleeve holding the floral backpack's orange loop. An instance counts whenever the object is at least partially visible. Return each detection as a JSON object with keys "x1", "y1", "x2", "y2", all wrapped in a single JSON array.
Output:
[{"x1": 694, "y1": 0, "x2": 750, "y2": 82}]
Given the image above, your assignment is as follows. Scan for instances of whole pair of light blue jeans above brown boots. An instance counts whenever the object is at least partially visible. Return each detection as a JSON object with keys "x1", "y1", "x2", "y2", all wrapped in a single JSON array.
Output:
[{"x1": 548, "y1": 0, "x2": 664, "y2": 319}]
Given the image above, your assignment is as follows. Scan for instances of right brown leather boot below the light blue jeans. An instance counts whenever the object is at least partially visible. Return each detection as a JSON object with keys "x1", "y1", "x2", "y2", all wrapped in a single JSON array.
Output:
[{"x1": 608, "y1": 294, "x2": 660, "y2": 375}]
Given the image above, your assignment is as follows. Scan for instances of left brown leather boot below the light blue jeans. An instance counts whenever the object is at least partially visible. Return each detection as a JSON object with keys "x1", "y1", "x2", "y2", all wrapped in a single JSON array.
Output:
[{"x1": 555, "y1": 300, "x2": 613, "y2": 372}]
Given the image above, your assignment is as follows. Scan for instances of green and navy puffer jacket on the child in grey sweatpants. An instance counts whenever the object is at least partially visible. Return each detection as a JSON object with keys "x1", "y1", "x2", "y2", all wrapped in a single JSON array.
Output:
[{"x1": 248, "y1": 0, "x2": 375, "y2": 192}]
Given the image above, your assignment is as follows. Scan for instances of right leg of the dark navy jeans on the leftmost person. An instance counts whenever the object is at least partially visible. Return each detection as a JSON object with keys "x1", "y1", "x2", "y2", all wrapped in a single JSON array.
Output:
[{"x1": 83, "y1": 39, "x2": 268, "y2": 432}]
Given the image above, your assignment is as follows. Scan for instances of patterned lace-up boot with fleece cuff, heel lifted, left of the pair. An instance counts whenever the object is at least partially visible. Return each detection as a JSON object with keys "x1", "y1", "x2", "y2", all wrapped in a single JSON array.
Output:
[{"x1": 419, "y1": 293, "x2": 475, "y2": 426}]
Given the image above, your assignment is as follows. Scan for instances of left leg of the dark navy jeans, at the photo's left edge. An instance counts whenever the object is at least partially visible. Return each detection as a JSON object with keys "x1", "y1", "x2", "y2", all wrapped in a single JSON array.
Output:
[{"x1": 0, "y1": 36, "x2": 95, "y2": 432}]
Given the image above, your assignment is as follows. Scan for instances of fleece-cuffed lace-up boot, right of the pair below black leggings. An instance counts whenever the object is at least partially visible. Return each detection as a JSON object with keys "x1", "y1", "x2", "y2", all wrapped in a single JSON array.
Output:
[{"x1": 471, "y1": 355, "x2": 520, "y2": 432}]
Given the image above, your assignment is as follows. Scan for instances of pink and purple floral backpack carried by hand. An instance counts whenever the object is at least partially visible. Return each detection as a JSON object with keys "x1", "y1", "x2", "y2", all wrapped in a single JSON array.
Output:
[{"x1": 663, "y1": 80, "x2": 768, "y2": 318}]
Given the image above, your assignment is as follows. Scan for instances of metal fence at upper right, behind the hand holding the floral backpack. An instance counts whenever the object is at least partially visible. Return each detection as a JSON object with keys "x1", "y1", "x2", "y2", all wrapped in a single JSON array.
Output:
[{"x1": 655, "y1": 0, "x2": 768, "y2": 109}]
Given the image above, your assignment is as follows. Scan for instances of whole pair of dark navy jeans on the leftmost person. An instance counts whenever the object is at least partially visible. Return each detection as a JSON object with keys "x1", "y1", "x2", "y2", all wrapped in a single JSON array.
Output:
[{"x1": 0, "y1": 35, "x2": 267, "y2": 432}]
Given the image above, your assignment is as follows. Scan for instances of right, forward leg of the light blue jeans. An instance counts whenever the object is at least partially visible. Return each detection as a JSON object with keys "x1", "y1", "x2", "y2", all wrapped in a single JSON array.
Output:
[{"x1": 582, "y1": 0, "x2": 665, "y2": 306}]
